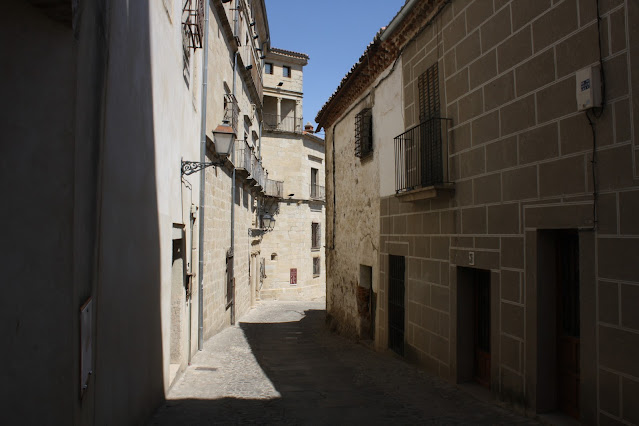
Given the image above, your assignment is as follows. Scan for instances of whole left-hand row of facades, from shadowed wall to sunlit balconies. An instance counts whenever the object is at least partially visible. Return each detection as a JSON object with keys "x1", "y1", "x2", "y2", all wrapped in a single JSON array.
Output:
[{"x1": 0, "y1": 0, "x2": 310, "y2": 425}]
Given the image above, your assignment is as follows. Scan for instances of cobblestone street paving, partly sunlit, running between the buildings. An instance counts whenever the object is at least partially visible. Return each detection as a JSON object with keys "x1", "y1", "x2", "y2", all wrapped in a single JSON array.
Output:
[{"x1": 149, "y1": 302, "x2": 536, "y2": 425}]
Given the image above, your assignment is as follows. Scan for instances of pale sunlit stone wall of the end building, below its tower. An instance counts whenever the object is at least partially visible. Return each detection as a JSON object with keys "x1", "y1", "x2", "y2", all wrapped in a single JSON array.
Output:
[{"x1": 259, "y1": 132, "x2": 326, "y2": 300}]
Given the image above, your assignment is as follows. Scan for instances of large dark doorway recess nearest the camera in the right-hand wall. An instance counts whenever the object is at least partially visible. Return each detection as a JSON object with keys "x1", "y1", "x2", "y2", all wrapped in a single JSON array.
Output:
[{"x1": 537, "y1": 230, "x2": 581, "y2": 418}]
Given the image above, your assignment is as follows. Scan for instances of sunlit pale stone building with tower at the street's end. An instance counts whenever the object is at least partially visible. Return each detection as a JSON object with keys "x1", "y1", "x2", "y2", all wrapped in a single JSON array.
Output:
[{"x1": 259, "y1": 48, "x2": 326, "y2": 300}]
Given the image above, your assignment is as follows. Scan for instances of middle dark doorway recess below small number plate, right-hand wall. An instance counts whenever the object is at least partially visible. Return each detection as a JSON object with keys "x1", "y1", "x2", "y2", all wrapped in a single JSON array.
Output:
[{"x1": 457, "y1": 267, "x2": 491, "y2": 389}]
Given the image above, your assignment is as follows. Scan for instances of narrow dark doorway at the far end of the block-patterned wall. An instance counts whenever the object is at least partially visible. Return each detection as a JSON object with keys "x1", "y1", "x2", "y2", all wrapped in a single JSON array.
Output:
[{"x1": 388, "y1": 255, "x2": 406, "y2": 356}]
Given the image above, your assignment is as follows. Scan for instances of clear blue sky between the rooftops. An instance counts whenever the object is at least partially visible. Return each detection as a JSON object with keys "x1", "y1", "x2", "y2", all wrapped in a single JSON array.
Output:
[{"x1": 265, "y1": 0, "x2": 404, "y2": 136}]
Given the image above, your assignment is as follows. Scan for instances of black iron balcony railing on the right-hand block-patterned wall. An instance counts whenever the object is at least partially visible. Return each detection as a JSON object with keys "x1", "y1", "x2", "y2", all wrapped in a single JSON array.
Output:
[{"x1": 395, "y1": 117, "x2": 451, "y2": 193}]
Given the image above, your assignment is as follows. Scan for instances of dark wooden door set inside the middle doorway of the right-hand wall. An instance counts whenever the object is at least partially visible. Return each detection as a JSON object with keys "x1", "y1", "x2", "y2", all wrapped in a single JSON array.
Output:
[{"x1": 473, "y1": 270, "x2": 490, "y2": 388}]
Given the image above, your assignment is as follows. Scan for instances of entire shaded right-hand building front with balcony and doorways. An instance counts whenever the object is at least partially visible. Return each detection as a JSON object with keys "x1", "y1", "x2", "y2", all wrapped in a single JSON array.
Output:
[{"x1": 317, "y1": 0, "x2": 639, "y2": 424}]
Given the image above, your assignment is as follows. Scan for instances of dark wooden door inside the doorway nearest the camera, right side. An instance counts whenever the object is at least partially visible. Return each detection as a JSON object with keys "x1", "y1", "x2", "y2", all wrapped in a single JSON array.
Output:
[{"x1": 557, "y1": 231, "x2": 580, "y2": 418}]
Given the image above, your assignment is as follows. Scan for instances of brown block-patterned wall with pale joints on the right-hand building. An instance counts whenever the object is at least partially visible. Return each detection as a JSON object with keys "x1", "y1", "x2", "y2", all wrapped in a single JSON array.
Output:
[{"x1": 380, "y1": 0, "x2": 639, "y2": 423}]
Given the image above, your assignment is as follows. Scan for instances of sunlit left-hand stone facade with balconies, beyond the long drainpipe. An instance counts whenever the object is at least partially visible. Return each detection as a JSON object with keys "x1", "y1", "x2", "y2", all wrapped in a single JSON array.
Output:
[{"x1": 202, "y1": 1, "x2": 270, "y2": 339}]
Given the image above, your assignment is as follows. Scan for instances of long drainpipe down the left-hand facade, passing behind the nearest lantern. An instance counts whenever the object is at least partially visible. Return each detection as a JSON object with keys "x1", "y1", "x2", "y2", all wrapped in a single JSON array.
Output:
[{"x1": 196, "y1": 1, "x2": 209, "y2": 351}]
